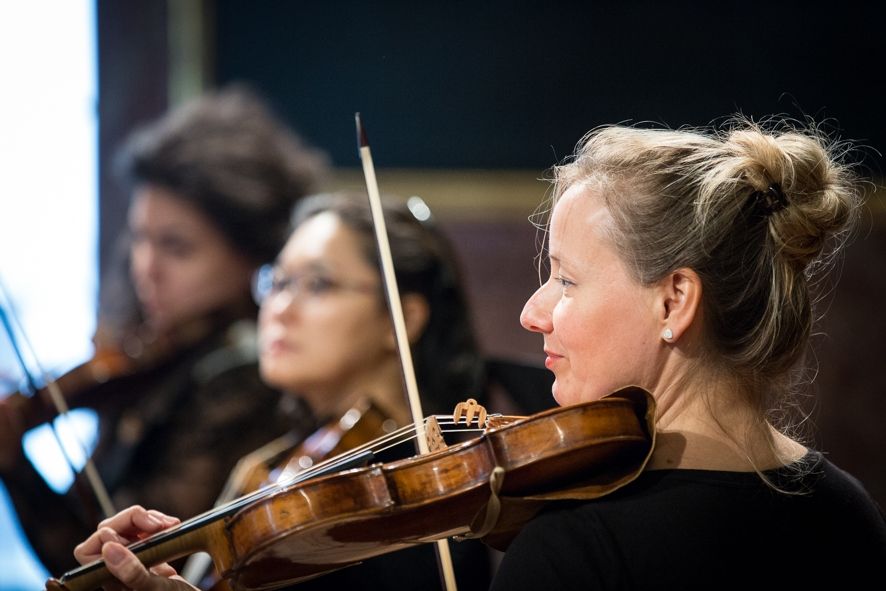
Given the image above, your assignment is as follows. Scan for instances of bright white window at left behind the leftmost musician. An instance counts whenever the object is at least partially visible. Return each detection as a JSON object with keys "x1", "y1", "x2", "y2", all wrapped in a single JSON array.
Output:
[{"x1": 0, "y1": 0, "x2": 98, "y2": 590}]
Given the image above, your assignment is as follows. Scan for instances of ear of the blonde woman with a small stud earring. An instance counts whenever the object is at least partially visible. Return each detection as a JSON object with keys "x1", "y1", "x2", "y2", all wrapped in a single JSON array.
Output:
[{"x1": 656, "y1": 267, "x2": 702, "y2": 343}]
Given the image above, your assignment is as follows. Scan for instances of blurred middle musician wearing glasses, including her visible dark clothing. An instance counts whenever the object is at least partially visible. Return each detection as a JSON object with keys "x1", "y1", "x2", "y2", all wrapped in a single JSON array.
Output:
[{"x1": 193, "y1": 192, "x2": 491, "y2": 589}]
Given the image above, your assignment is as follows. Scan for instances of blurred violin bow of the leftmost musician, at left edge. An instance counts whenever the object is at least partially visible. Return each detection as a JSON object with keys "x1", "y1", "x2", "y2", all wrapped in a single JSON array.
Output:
[{"x1": 0, "y1": 281, "x2": 116, "y2": 517}]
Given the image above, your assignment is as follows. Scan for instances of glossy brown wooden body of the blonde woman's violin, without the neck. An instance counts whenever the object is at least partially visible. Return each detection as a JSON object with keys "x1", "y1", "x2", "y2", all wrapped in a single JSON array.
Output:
[{"x1": 225, "y1": 390, "x2": 649, "y2": 589}]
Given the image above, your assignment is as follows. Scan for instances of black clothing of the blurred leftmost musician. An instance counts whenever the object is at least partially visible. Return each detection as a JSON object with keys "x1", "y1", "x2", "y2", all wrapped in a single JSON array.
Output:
[{"x1": 0, "y1": 321, "x2": 304, "y2": 576}]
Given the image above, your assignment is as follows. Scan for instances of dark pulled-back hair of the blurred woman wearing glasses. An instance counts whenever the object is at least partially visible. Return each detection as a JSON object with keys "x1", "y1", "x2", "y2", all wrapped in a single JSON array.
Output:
[{"x1": 293, "y1": 192, "x2": 485, "y2": 413}]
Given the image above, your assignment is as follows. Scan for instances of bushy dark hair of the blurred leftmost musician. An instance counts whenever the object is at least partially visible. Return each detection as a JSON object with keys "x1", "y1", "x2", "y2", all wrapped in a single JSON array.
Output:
[{"x1": 116, "y1": 84, "x2": 326, "y2": 263}]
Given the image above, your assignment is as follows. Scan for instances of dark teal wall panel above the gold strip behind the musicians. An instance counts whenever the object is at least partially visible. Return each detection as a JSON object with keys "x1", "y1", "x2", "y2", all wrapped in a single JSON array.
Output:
[{"x1": 216, "y1": 0, "x2": 886, "y2": 168}]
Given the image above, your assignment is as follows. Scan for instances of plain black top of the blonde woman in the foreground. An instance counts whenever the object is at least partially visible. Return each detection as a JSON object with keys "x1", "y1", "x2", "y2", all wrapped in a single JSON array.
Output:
[{"x1": 492, "y1": 452, "x2": 886, "y2": 591}]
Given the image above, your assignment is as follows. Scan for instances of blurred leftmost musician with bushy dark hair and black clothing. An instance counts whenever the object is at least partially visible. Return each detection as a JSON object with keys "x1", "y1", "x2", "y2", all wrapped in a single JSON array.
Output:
[{"x1": 0, "y1": 85, "x2": 326, "y2": 572}]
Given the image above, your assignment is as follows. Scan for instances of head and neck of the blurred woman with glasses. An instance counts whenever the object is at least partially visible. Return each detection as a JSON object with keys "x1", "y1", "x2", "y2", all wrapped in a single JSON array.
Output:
[{"x1": 256, "y1": 194, "x2": 490, "y2": 434}]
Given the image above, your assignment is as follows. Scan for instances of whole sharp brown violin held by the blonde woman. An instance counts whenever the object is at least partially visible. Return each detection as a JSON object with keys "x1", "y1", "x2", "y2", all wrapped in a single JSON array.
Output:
[{"x1": 46, "y1": 387, "x2": 654, "y2": 591}]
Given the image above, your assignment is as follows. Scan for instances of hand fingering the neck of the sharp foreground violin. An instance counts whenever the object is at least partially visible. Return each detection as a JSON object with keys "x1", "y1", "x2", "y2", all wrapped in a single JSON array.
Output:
[{"x1": 74, "y1": 505, "x2": 195, "y2": 591}]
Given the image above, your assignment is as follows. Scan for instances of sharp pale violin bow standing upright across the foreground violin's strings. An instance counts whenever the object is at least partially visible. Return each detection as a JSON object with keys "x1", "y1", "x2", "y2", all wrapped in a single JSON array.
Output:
[{"x1": 354, "y1": 113, "x2": 456, "y2": 591}]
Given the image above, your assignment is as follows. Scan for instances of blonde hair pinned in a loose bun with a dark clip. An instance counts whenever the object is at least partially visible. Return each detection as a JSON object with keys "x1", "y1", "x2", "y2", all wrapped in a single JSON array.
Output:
[{"x1": 553, "y1": 118, "x2": 862, "y2": 412}]
